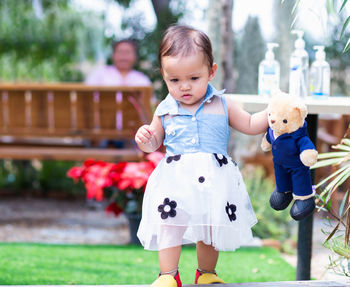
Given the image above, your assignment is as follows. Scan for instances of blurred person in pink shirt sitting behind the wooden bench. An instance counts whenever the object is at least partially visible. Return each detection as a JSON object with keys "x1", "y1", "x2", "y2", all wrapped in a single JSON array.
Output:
[{"x1": 85, "y1": 39, "x2": 151, "y2": 86}]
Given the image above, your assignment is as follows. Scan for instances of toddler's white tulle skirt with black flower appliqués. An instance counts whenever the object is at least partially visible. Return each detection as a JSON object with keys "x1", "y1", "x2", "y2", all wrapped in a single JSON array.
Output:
[{"x1": 137, "y1": 153, "x2": 257, "y2": 250}]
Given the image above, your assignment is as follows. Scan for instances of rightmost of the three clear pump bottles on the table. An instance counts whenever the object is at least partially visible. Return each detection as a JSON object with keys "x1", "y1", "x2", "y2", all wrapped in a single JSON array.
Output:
[{"x1": 310, "y1": 46, "x2": 331, "y2": 98}]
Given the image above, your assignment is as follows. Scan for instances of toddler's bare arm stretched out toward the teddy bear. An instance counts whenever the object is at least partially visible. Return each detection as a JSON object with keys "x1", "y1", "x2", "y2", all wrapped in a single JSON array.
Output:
[{"x1": 226, "y1": 97, "x2": 268, "y2": 135}]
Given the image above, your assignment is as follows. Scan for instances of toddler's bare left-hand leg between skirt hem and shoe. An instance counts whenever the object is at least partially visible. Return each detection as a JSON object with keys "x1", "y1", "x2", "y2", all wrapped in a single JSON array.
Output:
[{"x1": 158, "y1": 245, "x2": 181, "y2": 276}]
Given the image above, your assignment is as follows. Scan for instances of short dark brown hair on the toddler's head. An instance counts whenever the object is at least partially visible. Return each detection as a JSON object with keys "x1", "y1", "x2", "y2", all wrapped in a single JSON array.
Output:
[{"x1": 158, "y1": 25, "x2": 214, "y2": 69}]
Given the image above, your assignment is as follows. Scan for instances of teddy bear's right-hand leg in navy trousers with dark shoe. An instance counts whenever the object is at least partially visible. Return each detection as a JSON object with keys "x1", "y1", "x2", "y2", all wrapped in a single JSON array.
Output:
[{"x1": 290, "y1": 167, "x2": 316, "y2": 220}]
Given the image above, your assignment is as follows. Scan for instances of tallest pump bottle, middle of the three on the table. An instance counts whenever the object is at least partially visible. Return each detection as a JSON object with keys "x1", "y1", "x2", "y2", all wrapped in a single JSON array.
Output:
[{"x1": 289, "y1": 30, "x2": 309, "y2": 98}]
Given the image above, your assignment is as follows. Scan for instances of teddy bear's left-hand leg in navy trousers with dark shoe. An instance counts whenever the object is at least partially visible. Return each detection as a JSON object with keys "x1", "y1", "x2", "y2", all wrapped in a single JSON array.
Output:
[{"x1": 270, "y1": 163, "x2": 293, "y2": 210}]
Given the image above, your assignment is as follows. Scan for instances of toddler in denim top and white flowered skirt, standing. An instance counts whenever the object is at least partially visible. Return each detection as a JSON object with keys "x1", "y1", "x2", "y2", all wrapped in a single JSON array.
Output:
[{"x1": 135, "y1": 25, "x2": 268, "y2": 287}]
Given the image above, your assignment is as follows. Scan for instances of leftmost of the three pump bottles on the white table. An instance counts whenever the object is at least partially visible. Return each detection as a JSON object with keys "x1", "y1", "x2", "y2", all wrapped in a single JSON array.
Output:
[{"x1": 258, "y1": 43, "x2": 280, "y2": 96}]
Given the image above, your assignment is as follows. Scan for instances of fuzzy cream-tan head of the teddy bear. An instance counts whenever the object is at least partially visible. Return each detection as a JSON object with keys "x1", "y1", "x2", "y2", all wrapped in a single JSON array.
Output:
[{"x1": 267, "y1": 92, "x2": 307, "y2": 135}]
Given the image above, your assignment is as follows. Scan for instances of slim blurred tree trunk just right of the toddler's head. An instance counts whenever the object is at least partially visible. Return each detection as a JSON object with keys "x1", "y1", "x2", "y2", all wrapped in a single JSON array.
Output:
[{"x1": 220, "y1": 0, "x2": 235, "y2": 93}]
